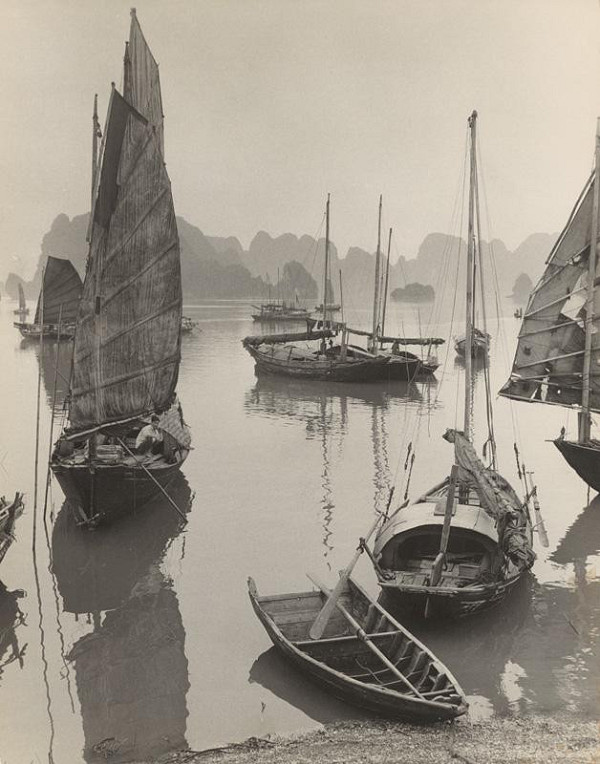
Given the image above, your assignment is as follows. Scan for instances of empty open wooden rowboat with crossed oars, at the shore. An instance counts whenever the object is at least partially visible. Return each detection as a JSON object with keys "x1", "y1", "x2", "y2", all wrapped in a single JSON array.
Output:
[{"x1": 248, "y1": 578, "x2": 467, "y2": 722}]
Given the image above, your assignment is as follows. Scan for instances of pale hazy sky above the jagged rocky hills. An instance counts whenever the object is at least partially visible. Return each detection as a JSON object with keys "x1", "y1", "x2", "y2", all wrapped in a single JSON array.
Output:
[{"x1": 0, "y1": 0, "x2": 600, "y2": 277}]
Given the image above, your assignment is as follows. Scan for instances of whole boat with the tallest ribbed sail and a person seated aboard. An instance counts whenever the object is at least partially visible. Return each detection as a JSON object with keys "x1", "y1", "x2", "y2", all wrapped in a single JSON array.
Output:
[{"x1": 50, "y1": 10, "x2": 190, "y2": 526}]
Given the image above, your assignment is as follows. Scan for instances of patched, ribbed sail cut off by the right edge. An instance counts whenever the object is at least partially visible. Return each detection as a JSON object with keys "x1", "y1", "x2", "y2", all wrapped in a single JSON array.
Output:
[{"x1": 500, "y1": 173, "x2": 600, "y2": 411}]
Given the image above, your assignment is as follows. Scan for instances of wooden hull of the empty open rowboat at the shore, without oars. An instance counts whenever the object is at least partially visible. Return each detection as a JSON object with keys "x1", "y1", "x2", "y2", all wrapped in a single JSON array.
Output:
[{"x1": 249, "y1": 581, "x2": 467, "y2": 722}]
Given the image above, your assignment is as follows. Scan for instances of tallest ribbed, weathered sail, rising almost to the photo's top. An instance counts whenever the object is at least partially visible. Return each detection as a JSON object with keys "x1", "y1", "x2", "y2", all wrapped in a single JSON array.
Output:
[{"x1": 70, "y1": 14, "x2": 181, "y2": 430}]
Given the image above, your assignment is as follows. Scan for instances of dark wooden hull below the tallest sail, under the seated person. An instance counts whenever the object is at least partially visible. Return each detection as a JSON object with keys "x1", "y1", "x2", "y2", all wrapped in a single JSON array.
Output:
[{"x1": 50, "y1": 453, "x2": 187, "y2": 527}]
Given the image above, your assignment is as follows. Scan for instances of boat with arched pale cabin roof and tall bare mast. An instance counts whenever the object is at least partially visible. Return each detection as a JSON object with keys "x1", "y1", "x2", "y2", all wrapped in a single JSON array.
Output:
[{"x1": 371, "y1": 112, "x2": 535, "y2": 617}]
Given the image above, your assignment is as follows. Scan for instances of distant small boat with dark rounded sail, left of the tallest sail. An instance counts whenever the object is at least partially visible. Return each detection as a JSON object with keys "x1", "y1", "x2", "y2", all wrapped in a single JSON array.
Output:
[{"x1": 14, "y1": 256, "x2": 83, "y2": 340}]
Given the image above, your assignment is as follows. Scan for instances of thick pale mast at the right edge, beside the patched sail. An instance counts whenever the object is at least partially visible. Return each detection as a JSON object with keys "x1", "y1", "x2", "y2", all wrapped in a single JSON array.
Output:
[{"x1": 578, "y1": 118, "x2": 600, "y2": 443}]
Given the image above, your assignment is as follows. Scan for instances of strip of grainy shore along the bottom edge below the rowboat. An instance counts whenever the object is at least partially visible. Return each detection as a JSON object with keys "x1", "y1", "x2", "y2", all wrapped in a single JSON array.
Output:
[{"x1": 150, "y1": 716, "x2": 600, "y2": 764}]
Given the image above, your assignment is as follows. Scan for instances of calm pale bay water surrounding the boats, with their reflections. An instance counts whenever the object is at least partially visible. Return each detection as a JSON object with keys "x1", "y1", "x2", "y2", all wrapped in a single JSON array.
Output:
[{"x1": 0, "y1": 301, "x2": 600, "y2": 764}]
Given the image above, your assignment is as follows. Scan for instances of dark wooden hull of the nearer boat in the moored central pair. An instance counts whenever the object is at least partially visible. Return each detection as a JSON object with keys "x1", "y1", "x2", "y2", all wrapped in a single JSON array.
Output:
[{"x1": 245, "y1": 345, "x2": 388, "y2": 382}]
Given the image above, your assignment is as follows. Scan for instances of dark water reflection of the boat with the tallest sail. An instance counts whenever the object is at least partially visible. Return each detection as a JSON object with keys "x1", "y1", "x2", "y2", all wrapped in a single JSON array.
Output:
[{"x1": 52, "y1": 475, "x2": 190, "y2": 762}]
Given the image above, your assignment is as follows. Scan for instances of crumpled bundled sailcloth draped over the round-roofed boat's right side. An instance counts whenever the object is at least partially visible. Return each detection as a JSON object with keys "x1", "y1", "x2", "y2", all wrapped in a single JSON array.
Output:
[{"x1": 444, "y1": 430, "x2": 535, "y2": 569}]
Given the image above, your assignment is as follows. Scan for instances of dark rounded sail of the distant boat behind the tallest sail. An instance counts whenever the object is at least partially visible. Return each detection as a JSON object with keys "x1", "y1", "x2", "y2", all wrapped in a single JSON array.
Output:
[{"x1": 34, "y1": 257, "x2": 83, "y2": 324}]
